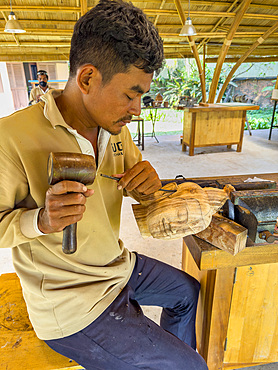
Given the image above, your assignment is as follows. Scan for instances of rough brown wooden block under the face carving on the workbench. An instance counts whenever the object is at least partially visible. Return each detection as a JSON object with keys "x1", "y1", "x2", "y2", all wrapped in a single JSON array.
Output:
[{"x1": 196, "y1": 213, "x2": 247, "y2": 256}]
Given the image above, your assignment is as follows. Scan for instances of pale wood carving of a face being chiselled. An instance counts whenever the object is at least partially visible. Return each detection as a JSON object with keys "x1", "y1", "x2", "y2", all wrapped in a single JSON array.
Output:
[{"x1": 130, "y1": 182, "x2": 234, "y2": 239}]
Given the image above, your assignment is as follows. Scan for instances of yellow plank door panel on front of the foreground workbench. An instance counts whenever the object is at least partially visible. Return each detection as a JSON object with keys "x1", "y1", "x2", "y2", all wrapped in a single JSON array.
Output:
[{"x1": 224, "y1": 263, "x2": 278, "y2": 364}]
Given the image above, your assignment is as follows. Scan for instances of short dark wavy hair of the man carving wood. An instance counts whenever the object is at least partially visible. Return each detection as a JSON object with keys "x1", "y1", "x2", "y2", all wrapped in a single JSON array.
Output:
[{"x1": 70, "y1": 0, "x2": 164, "y2": 84}]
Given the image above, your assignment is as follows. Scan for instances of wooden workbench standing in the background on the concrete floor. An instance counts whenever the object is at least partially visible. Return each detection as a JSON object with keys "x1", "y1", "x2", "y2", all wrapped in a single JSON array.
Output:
[{"x1": 182, "y1": 103, "x2": 260, "y2": 156}]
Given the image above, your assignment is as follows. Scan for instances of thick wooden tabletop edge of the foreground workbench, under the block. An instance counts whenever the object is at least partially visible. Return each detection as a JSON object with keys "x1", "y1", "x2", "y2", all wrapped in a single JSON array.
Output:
[{"x1": 183, "y1": 235, "x2": 278, "y2": 270}]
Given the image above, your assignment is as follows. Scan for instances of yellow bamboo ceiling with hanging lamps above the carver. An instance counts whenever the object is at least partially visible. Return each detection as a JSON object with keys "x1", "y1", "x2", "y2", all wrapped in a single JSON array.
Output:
[{"x1": 0, "y1": 0, "x2": 278, "y2": 63}]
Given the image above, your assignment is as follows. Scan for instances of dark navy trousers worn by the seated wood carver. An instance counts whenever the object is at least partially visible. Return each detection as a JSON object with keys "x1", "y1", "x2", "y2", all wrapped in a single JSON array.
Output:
[{"x1": 45, "y1": 254, "x2": 207, "y2": 370}]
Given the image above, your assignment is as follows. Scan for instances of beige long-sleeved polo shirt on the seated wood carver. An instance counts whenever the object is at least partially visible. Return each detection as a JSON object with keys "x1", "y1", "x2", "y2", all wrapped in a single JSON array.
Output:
[{"x1": 0, "y1": 90, "x2": 141, "y2": 339}]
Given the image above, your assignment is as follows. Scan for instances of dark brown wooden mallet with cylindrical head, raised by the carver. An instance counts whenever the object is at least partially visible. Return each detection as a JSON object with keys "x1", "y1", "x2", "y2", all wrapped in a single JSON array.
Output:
[{"x1": 47, "y1": 152, "x2": 96, "y2": 254}]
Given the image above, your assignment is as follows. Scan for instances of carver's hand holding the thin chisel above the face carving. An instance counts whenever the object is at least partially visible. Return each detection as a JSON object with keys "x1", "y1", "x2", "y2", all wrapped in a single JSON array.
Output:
[{"x1": 118, "y1": 161, "x2": 161, "y2": 195}]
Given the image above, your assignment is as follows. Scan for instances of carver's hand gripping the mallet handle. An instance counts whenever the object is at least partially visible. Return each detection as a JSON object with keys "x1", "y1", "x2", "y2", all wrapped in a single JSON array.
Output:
[{"x1": 38, "y1": 181, "x2": 94, "y2": 234}]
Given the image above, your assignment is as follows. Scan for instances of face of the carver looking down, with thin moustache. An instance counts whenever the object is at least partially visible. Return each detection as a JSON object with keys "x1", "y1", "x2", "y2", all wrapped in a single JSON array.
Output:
[{"x1": 84, "y1": 66, "x2": 153, "y2": 135}]
